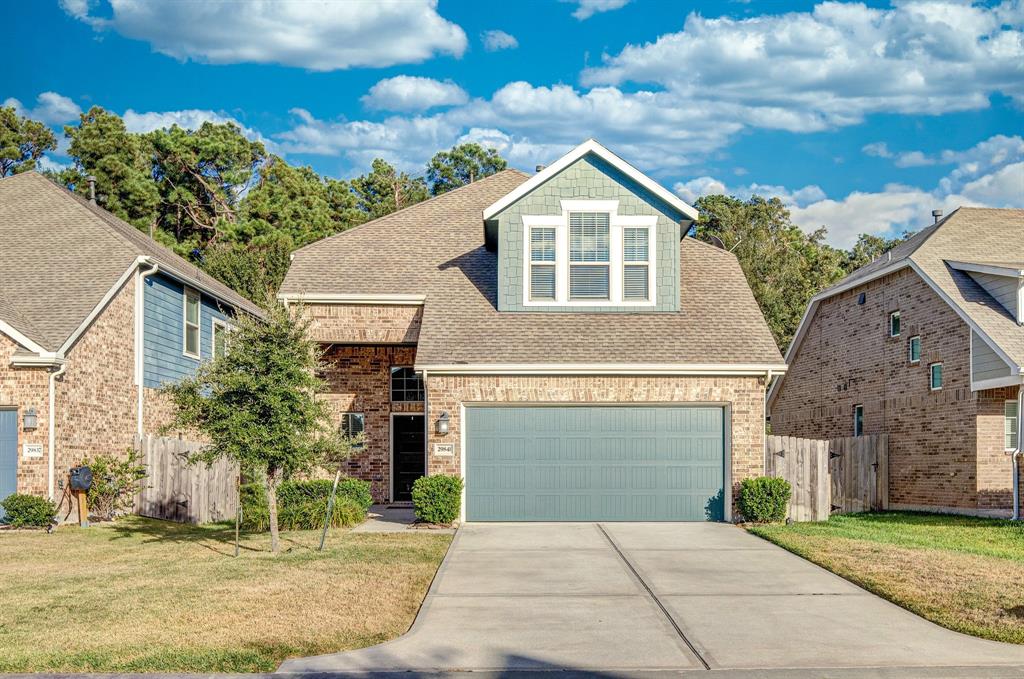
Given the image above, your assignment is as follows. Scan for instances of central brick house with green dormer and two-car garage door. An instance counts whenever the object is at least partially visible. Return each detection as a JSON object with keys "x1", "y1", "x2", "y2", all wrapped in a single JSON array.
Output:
[{"x1": 281, "y1": 140, "x2": 785, "y2": 520}]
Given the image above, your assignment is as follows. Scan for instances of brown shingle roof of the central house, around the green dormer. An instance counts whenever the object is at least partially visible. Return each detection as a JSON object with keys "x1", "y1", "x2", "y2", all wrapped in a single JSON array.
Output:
[{"x1": 282, "y1": 170, "x2": 782, "y2": 365}]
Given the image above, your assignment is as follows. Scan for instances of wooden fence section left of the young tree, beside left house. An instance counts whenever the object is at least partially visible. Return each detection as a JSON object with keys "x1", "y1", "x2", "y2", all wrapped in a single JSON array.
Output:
[{"x1": 135, "y1": 434, "x2": 239, "y2": 523}]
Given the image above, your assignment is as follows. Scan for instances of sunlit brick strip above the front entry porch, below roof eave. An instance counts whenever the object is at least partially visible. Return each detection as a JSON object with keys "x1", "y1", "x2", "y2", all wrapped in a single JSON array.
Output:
[{"x1": 302, "y1": 304, "x2": 423, "y2": 344}]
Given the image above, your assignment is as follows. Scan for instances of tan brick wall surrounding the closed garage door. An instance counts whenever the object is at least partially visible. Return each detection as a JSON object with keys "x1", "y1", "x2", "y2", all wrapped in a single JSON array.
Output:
[{"x1": 419, "y1": 375, "x2": 764, "y2": 512}]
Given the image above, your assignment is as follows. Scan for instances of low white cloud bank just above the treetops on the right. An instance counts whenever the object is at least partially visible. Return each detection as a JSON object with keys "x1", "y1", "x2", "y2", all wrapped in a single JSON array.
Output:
[{"x1": 673, "y1": 135, "x2": 1024, "y2": 248}]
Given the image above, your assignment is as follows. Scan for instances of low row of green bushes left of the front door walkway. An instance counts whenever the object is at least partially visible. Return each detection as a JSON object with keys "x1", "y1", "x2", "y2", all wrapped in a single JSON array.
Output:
[{"x1": 241, "y1": 478, "x2": 373, "y2": 531}]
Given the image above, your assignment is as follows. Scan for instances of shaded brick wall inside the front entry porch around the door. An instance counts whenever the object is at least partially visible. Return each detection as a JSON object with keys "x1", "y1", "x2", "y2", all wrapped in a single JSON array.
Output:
[{"x1": 323, "y1": 344, "x2": 423, "y2": 502}]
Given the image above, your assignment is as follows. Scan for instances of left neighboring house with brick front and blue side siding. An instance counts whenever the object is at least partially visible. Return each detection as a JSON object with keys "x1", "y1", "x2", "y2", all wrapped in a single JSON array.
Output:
[{"x1": 0, "y1": 172, "x2": 261, "y2": 515}]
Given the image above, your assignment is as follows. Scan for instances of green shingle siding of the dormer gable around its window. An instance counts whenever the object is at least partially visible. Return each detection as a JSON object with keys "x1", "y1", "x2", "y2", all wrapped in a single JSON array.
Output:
[{"x1": 498, "y1": 155, "x2": 685, "y2": 313}]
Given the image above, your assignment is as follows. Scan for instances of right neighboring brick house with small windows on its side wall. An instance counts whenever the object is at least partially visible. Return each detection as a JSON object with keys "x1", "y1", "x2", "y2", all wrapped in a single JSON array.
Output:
[{"x1": 768, "y1": 208, "x2": 1024, "y2": 514}]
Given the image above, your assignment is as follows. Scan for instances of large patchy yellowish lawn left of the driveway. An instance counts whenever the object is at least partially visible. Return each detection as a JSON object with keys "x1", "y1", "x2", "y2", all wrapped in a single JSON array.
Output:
[{"x1": 0, "y1": 517, "x2": 451, "y2": 672}]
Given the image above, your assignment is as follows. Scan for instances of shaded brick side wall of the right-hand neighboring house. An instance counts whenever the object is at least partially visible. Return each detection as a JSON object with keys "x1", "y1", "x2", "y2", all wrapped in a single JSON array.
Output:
[{"x1": 771, "y1": 269, "x2": 1010, "y2": 510}]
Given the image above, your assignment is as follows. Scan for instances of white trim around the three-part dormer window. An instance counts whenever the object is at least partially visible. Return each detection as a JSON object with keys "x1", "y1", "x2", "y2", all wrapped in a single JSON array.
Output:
[{"x1": 522, "y1": 200, "x2": 657, "y2": 307}]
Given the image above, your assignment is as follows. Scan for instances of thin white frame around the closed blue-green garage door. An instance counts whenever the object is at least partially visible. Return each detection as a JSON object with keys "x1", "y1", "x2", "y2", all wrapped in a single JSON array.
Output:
[{"x1": 459, "y1": 400, "x2": 732, "y2": 523}]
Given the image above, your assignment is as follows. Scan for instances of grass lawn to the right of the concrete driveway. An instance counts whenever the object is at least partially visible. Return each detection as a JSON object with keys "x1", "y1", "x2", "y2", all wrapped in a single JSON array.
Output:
[{"x1": 749, "y1": 512, "x2": 1024, "y2": 643}]
